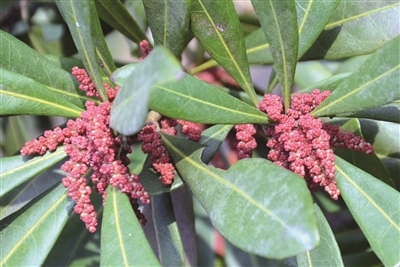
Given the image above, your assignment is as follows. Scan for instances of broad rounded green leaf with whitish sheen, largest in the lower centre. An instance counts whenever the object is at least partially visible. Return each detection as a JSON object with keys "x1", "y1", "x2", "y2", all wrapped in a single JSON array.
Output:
[{"x1": 162, "y1": 134, "x2": 319, "y2": 259}]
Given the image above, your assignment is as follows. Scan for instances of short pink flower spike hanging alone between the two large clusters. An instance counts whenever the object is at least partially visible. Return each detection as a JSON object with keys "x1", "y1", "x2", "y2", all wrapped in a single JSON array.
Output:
[{"x1": 235, "y1": 124, "x2": 257, "y2": 160}]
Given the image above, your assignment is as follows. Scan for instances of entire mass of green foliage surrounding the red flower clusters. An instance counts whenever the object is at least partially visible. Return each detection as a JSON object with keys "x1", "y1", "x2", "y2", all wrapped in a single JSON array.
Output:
[{"x1": 0, "y1": 0, "x2": 400, "y2": 266}]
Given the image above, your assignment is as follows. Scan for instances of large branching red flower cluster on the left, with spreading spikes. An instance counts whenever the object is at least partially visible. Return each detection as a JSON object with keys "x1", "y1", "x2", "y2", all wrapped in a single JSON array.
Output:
[{"x1": 21, "y1": 67, "x2": 150, "y2": 232}]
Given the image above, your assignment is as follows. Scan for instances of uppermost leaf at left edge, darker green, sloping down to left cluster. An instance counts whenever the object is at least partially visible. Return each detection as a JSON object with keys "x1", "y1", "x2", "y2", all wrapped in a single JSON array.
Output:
[{"x1": 0, "y1": 31, "x2": 87, "y2": 108}]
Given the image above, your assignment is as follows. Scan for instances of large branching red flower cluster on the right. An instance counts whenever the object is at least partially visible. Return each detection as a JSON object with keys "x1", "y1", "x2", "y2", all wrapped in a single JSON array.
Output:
[{"x1": 258, "y1": 90, "x2": 373, "y2": 200}]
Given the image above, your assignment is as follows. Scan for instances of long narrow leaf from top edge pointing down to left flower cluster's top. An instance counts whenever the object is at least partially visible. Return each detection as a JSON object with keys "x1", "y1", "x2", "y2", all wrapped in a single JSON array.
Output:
[{"x1": 56, "y1": 0, "x2": 108, "y2": 100}]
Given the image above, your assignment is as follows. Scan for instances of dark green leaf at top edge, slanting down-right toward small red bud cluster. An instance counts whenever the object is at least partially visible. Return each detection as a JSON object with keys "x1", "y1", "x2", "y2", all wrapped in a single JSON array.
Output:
[{"x1": 94, "y1": 0, "x2": 147, "y2": 44}]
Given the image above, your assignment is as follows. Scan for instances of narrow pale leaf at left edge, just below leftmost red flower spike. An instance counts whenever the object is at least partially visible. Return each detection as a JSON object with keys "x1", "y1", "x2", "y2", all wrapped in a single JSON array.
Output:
[{"x1": 0, "y1": 147, "x2": 66, "y2": 197}]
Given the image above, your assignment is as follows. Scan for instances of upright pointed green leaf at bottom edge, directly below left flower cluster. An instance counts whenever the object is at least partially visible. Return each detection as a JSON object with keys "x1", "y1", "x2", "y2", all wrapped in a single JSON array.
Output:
[{"x1": 100, "y1": 186, "x2": 160, "y2": 266}]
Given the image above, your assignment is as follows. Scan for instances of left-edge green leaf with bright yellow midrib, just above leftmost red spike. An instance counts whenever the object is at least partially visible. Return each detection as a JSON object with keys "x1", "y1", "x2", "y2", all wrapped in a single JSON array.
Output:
[{"x1": 0, "y1": 69, "x2": 83, "y2": 117}]
